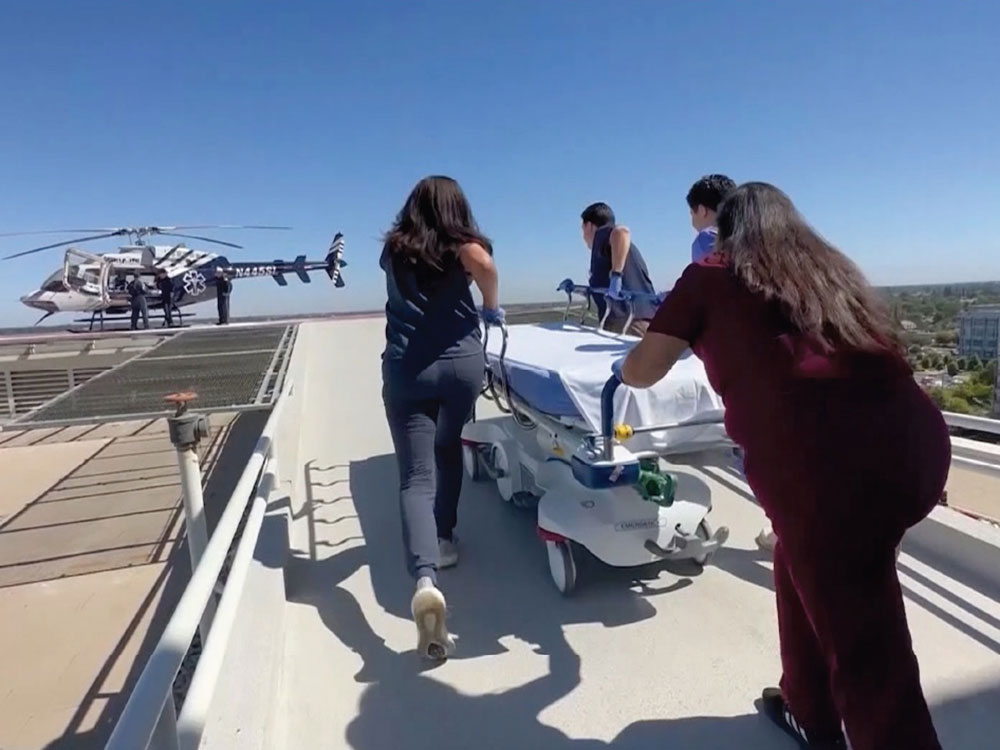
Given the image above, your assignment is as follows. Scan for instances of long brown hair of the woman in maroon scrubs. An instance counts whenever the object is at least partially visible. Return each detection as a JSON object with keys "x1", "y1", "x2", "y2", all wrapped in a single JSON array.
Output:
[{"x1": 717, "y1": 182, "x2": 902, "y2": 353}]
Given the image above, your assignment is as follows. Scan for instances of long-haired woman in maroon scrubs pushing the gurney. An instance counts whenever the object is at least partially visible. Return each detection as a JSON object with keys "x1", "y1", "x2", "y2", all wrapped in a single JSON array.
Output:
[{"x1": 618, "y1": 183, "x2": 951, "y2": 750}]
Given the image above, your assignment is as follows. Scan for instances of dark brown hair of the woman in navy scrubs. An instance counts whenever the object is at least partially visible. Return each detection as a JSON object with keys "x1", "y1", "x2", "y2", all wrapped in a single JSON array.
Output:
[{"x1": 385, "y1": 175, "x2": 493, "y2": 269}]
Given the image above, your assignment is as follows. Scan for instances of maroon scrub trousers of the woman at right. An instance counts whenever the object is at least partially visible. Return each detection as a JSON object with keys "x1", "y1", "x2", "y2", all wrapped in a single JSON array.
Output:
[{"x1": 745, "y1": 388, "x2": 951, "y2": 750}]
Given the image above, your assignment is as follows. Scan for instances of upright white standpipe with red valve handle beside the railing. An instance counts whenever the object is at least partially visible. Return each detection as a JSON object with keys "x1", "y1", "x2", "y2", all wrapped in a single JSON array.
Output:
[{"x1": 166, "y1": 393, "x2": 215, "y2": 642}]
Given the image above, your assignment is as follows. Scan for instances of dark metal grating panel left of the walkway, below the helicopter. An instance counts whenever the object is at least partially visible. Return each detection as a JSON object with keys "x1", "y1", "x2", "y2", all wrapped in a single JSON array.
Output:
[{"x1": 14, "y1": 326, "x2": 295, "y2": 427}]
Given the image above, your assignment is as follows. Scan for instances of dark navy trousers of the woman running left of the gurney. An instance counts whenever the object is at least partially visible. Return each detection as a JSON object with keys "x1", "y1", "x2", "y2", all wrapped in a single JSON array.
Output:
[{"x1": 382, "y1": 355, "x2": 485, "y2": 581}]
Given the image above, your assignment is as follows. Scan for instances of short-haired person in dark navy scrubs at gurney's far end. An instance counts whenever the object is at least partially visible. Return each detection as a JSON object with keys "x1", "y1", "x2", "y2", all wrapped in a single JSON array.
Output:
[{"x1": 580, "y1": 203, "x2": 656, "y2": 336}]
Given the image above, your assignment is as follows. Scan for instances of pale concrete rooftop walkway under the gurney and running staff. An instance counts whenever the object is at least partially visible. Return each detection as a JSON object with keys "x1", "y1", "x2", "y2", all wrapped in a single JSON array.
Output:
[{"x1": 275, "y1": 319, "x2": 1000, "y2": 750}]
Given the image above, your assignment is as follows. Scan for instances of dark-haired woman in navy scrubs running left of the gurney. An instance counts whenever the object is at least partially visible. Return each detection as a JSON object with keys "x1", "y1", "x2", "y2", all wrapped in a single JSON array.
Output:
[{"x1": 380, "y1": 177, "x2": 504, "y2": 659}]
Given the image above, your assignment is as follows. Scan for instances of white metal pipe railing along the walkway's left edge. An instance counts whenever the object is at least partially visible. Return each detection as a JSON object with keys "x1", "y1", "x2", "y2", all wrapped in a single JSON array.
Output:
[{"x1": 105, "y1": 380, "x2": 294, "y2": 750}]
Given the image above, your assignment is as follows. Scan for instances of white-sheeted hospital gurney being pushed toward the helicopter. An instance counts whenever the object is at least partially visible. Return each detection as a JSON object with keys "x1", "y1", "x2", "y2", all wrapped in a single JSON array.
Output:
[{"x1": 462, "y1": 282, "x2": 733, "y2": 594}]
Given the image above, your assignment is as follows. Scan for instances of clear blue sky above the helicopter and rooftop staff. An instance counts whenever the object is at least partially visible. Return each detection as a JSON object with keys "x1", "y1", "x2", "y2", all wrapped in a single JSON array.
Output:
[{"x1": 0, "y1": 0, "x2": 1000, "y2": 325}]
